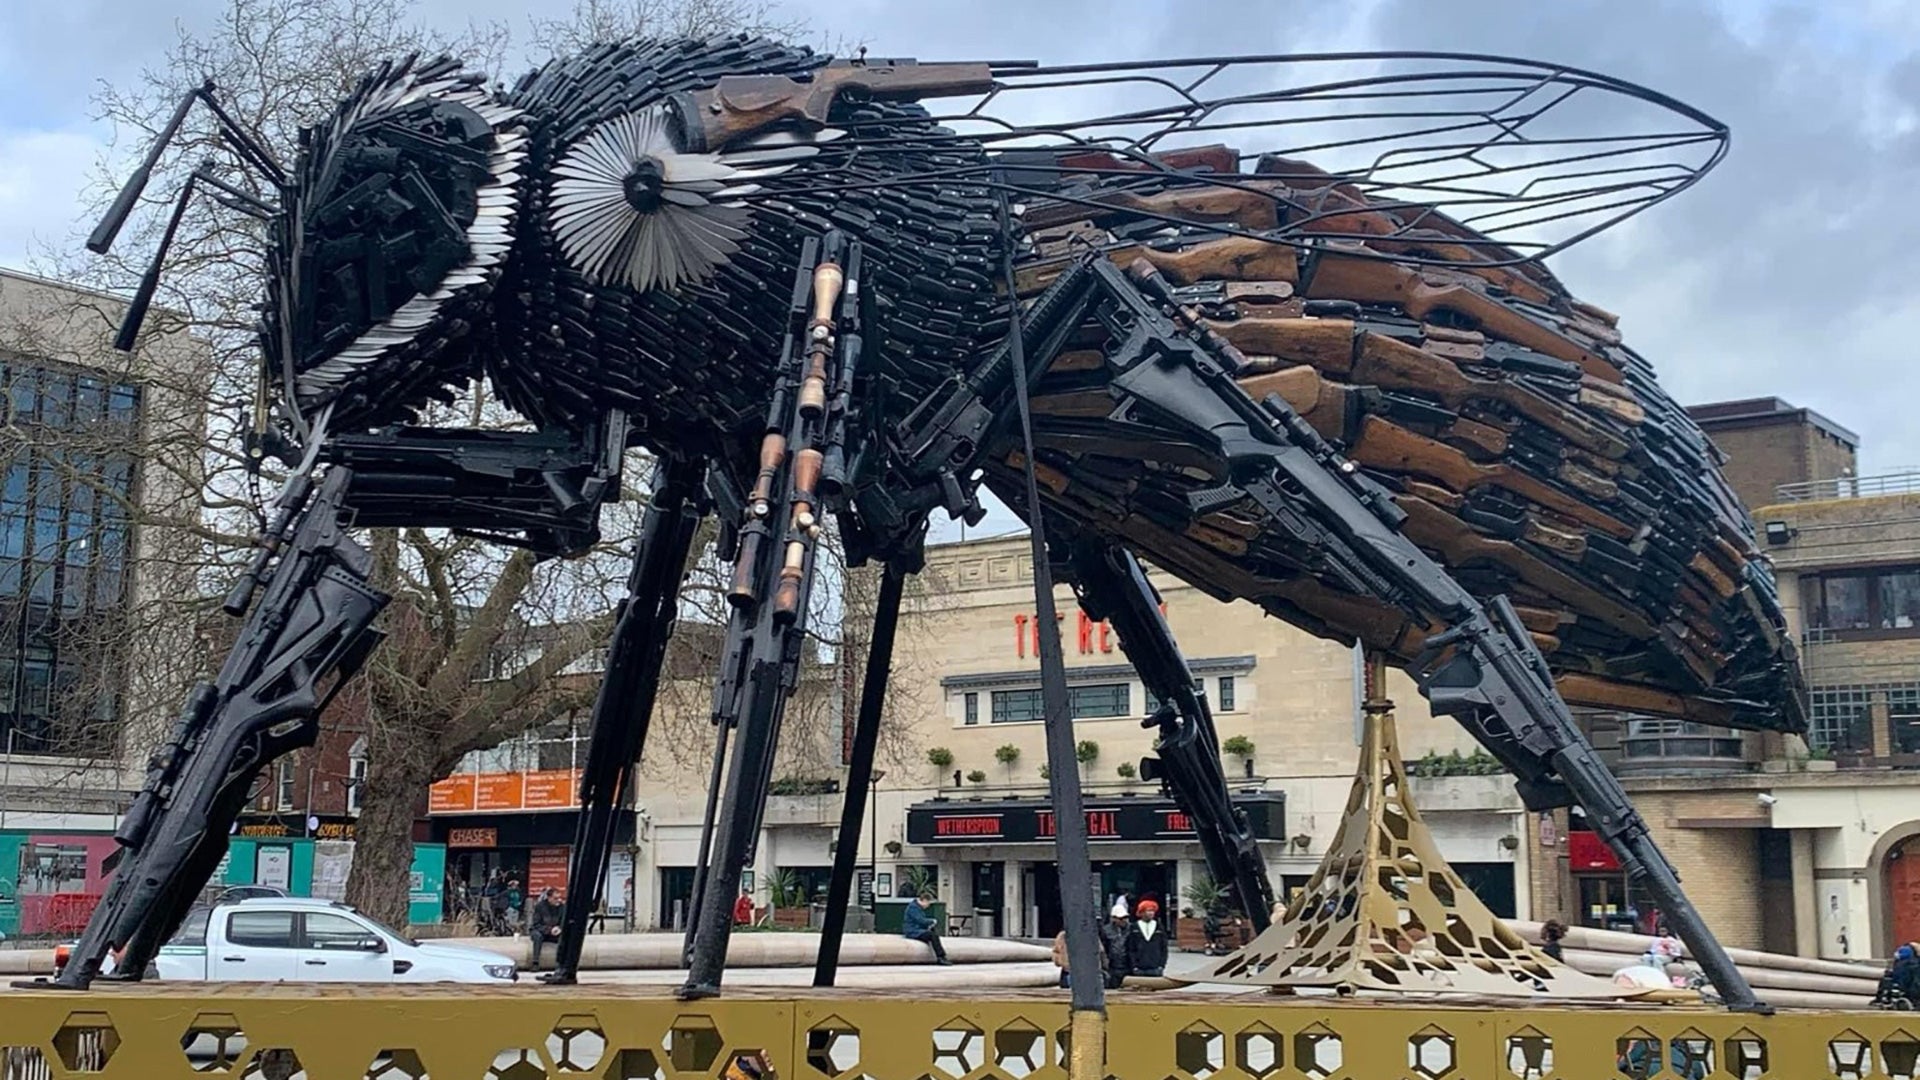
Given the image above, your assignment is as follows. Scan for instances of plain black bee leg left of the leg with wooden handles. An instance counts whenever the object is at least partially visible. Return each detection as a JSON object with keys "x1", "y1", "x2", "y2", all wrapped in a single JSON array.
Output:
[{"x1": 543, "y1": 459, "x2": 707, "y2": 984}]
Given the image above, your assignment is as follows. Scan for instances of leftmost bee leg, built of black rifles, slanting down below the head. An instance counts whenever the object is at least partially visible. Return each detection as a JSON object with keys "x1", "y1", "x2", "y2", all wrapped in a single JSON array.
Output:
[{"x1": 56, "y1": 469, "x2": 388, "y2": 990}]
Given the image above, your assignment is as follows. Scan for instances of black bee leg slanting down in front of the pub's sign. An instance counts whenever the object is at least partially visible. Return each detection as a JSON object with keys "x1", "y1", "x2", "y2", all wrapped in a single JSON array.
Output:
[{"x1": 1069, "y1": 534, "x2": 1273, "y2": 932}]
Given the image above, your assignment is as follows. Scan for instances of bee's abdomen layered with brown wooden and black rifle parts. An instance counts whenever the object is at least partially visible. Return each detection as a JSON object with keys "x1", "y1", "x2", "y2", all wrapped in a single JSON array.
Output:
[{"x1": 1002, "y1": 158, "x2": 1801, "y2": 728}]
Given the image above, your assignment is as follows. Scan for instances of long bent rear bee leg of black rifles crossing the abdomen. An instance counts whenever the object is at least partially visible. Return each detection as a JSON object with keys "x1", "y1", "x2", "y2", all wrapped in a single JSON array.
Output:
[{"x1": 1006, "y1": 261, "x2": 1766, "y2": 1011}]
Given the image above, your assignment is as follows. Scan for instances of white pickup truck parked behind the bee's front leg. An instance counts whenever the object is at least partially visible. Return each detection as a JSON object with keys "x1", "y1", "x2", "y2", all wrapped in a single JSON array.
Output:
[{"x1": 154, "y1": 897, "x2": 520, "y2": 984}]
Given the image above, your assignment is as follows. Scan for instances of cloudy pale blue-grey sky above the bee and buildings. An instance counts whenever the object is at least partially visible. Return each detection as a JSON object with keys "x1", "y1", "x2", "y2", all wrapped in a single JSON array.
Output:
[{"x1": 0, "y1": 0, "x2": 1920, "y2": 534}]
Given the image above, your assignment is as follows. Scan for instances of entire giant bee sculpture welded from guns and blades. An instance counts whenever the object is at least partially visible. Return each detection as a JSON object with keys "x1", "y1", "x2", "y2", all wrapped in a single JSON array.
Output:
[{"x1": 61, "y1": 38, "x2": 1803, "y2": 1005}]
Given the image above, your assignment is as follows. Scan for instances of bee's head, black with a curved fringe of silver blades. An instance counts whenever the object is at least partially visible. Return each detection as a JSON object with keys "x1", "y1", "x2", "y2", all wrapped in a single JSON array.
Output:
[{"x1": 265, "y1": 60, "x2": 526, "y2": 425}]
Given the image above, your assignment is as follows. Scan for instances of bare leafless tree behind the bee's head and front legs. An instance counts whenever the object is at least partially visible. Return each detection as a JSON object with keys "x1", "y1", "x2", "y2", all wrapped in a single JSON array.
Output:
[{"x1": 26, "y1": 0, "x2": 871, "y2": 920}]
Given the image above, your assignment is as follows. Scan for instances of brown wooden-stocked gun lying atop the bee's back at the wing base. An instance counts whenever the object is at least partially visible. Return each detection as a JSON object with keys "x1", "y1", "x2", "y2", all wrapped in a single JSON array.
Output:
[{"x1": 674, "y1": 60, "x2": 993, "y2": 154}]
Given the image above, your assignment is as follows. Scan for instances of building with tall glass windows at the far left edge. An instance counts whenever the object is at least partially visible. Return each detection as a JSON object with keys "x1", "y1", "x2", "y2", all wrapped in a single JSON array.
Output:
[{"x1": 0, "y1": 269, "x2": 207, "y2": 934}]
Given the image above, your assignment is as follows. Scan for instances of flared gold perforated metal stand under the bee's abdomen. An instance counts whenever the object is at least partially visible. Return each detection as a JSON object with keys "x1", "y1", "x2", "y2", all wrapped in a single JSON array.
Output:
[{"x1": 1190, "y1": 657, "x2": 1622, "y2": 997}]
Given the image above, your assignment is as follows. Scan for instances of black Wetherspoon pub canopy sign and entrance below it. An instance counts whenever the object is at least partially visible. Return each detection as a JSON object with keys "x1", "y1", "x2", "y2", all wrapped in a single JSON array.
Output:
[{"x1": 906, "y1": 792, "x2": 1286, "y2": 938}]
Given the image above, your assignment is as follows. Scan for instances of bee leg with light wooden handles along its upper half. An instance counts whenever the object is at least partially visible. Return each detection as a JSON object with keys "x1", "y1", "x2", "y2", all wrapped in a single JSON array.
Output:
[{"x1": 680, "y1": 231, "x2": 860, "y2": 999}]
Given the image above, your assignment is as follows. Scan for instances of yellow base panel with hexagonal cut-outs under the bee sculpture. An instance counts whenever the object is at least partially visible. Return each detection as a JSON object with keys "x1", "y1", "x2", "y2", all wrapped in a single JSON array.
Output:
[{"x1": 0, "y1": 984, "x2": 1920, "y2": 1080}]
